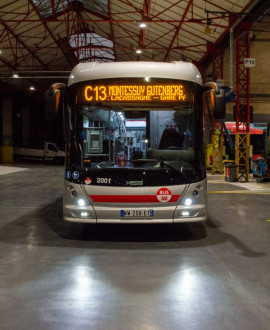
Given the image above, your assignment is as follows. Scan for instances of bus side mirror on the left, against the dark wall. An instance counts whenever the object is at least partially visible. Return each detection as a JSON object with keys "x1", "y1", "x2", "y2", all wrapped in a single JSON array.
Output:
[{"x1": 45, "y1": 83, "x2": 66, "y2": 120}]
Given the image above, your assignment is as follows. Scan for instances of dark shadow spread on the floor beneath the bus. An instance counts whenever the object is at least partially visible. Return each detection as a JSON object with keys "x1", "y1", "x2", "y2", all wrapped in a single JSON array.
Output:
[{"x1": 0, "y1": 198, "x2": 263, "y2": 257}]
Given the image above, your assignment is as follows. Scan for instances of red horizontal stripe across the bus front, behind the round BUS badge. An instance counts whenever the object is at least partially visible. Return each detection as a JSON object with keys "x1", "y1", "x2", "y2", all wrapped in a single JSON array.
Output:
[{"x1": 89, "y1": 195, "x2": 180, "y2": 203}]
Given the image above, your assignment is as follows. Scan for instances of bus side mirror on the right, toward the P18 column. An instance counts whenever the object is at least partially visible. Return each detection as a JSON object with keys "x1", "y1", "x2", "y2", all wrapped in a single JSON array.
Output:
[{"x1": 204, "y1": 82, "x2": 226, "y2": 119}]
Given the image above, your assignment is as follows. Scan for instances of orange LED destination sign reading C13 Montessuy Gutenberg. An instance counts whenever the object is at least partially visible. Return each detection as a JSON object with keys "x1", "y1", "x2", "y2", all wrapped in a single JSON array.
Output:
[{"x1": 84, "y1": 84, "x2": 187, "y2": 102}]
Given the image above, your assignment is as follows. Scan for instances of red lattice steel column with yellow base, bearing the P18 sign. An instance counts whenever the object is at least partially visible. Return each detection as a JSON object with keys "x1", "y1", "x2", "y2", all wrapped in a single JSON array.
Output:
[{"x1": 235, "y1": 22, "x2": 250, "y2": 181}]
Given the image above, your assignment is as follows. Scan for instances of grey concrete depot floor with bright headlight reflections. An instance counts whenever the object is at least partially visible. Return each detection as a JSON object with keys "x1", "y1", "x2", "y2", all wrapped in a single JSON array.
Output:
[{"x1": 0, "y1": 164, "x2": 270, "y2": 330}]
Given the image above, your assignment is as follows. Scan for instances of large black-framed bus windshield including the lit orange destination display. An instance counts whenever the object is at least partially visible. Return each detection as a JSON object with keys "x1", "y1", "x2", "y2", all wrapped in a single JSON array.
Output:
[{"x1": 66, "y1": 81, "x2": 205, "y2": 186}]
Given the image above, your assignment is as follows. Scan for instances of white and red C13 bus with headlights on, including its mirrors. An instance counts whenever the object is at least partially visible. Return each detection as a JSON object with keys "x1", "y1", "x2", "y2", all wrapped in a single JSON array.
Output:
[{"x1": 47, "y1": 62, "x2": 225, "y2": 223}]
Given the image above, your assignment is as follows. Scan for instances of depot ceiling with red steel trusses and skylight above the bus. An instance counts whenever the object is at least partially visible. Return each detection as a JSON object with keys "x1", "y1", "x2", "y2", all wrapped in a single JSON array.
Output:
[{"x1": 0, "y1": 0, "x2": 269, "y2": 89}]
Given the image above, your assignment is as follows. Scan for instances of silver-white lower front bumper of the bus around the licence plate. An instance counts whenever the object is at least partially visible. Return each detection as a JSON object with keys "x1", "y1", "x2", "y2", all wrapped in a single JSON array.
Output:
[{"x1": 63, "y1": 180, "x2": 207, "y2": 224}]
